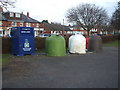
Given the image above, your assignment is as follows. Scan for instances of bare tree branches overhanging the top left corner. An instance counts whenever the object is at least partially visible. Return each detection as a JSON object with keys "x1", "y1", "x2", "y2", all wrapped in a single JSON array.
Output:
[{"x1": 0, "y1": 0, "x2": 16, "y2": 9}]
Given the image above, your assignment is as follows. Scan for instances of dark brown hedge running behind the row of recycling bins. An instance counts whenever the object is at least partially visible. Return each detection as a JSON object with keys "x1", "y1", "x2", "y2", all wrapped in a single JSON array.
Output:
[{"x1": 2, "y1": 35, "x2": 120, "y2": 53}]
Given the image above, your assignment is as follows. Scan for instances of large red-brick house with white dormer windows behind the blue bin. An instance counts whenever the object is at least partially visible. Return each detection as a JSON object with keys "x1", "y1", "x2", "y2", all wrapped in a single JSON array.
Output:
[{"x1": 0, "y1": 7, "x2": 44, "y2": 37}]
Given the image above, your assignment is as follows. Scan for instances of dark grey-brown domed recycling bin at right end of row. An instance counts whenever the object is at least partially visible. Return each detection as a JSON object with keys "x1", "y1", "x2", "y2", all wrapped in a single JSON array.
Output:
[{"x1": 88, "y1": 34, "x2": 102, "y2": 52}]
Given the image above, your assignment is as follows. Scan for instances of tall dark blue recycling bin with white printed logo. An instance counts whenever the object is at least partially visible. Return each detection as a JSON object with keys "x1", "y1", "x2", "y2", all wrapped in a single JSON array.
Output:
[{"x1": 11, "y1": 27, "x2": 34, "y2": 56}]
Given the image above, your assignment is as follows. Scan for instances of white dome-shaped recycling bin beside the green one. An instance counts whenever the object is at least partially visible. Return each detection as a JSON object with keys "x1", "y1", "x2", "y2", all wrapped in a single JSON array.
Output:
[{"x1": 68, "y1": 34, "x2": 86, "y2": 54}]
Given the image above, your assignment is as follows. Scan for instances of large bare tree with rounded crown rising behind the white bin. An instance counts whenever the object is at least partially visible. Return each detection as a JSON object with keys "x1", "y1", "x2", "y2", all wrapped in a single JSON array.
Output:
[{"x1": 66, "y1": 4, "x2": 108, "y2": 36}]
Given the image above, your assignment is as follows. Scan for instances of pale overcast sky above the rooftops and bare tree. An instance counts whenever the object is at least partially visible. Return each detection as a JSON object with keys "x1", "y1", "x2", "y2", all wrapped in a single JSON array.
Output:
[{"x1": 9, "y1": 0, "x2": 120, "y2": 24}]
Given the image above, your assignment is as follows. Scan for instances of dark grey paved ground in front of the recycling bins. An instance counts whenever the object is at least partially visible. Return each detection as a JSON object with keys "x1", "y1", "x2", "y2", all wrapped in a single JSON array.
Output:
[{"x1": 3, "y1": 47, "x2": 118, "y2": 88}]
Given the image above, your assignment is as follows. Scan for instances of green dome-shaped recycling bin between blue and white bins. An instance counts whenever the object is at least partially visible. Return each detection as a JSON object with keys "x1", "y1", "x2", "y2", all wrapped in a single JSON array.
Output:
[{"x1": 46, "y1": 35, "x2": 66, "y2": 56}]
